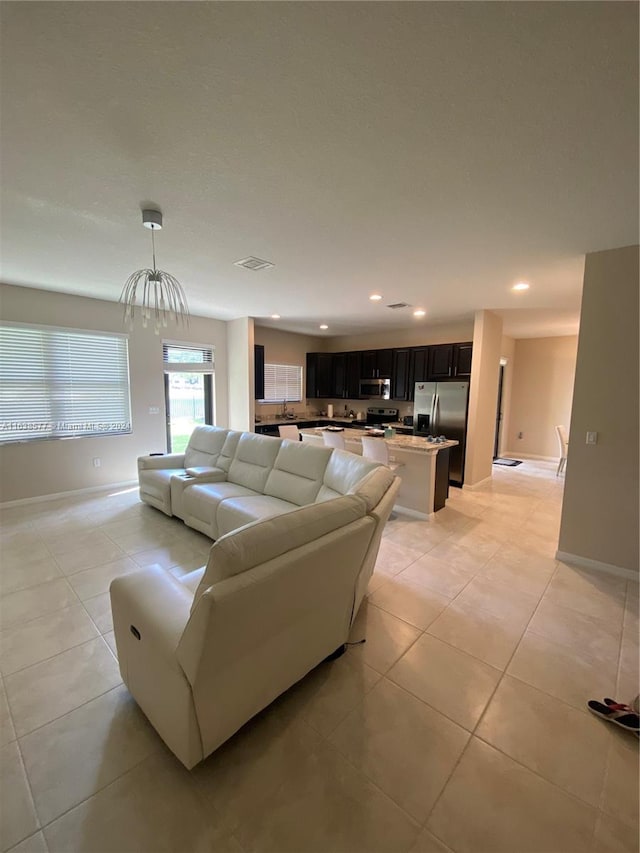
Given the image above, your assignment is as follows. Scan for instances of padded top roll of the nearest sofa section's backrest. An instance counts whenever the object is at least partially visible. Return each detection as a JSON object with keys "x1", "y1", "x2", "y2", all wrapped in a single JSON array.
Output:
[{"x1": 191, "y1": 495, "x2": 366, "y2": 612}]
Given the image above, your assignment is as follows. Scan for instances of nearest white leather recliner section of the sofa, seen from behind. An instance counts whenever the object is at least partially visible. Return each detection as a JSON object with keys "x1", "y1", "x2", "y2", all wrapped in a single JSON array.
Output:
[{"x1": 111, "y1": 466, "x2": 399, "y2": 768}]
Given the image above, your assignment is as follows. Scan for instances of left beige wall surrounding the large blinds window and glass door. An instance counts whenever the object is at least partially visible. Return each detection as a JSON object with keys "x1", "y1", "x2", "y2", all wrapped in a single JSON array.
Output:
[{"x1": 0, "y1": 284, "x2": 227, "y2": 502}]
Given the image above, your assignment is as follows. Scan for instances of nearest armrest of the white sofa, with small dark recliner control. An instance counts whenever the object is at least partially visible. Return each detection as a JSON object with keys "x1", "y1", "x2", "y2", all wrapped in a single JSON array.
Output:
[{"x1": 109, "y1": 566, "x2": 193, "y2": 661}]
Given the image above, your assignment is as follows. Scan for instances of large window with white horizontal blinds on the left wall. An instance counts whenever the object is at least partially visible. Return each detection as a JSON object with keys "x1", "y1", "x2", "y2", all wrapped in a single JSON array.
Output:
[{"x1": 0, "y1": 323, "x2": 131, "y2": 442}]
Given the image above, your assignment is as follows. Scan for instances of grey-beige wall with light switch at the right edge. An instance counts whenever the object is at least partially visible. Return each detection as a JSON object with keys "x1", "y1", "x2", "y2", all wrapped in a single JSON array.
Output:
[{"x1": 558, "y1": 246, "x2": 640, "y2": 575}]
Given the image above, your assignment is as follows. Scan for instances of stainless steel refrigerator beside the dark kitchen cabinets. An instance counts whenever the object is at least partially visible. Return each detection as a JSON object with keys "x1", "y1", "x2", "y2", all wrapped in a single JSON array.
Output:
[{"x1": 413, "y1": 382, "x2": 469, "y2": 486}]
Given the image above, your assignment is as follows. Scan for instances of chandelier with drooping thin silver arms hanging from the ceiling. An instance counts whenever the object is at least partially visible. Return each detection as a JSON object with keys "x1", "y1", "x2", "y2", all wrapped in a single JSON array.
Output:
[{"x1": 120, "y1": 210, "x2": 189, "y2": 335}]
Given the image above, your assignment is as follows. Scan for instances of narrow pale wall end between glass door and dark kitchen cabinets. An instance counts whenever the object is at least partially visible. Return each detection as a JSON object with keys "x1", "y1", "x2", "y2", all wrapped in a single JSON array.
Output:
[{"x1": 227, "y1": 317, "x2": 255, "y2": 432}]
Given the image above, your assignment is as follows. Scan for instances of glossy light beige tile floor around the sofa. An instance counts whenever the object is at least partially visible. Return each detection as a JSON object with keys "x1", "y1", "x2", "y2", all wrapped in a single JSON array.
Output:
[{"x1": 0, "y1": 462, "x2": 638, "y2": 853}]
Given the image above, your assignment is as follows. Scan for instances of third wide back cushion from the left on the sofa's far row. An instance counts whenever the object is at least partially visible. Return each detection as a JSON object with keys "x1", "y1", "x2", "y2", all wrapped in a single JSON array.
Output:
[{"x1": 264, "y1": 441, "x2": 331, "y2": 506}]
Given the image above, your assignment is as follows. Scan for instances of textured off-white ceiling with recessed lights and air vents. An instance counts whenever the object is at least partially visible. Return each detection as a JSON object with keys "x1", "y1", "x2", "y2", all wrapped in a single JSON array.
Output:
[{"x1": 1, "y1": 2, "x2": 638, "y2": 336}]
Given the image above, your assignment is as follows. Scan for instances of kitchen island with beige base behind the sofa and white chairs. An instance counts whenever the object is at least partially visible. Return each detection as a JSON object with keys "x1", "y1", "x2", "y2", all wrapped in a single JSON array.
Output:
[{"x1": 300, "y1": 428, "x2": 458, "y2": 519}]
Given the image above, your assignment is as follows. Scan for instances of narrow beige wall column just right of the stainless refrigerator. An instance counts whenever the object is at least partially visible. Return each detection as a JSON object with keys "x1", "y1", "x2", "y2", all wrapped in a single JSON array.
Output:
[{"x1": 464, "y1": 311, "x2": 502, "y2": 486}]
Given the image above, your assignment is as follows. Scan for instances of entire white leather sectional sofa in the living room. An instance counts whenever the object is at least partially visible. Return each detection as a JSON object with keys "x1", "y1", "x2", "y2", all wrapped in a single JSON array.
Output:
[{"x1": 111, "y1": 427, "x2": 400, "y2": 767}]
